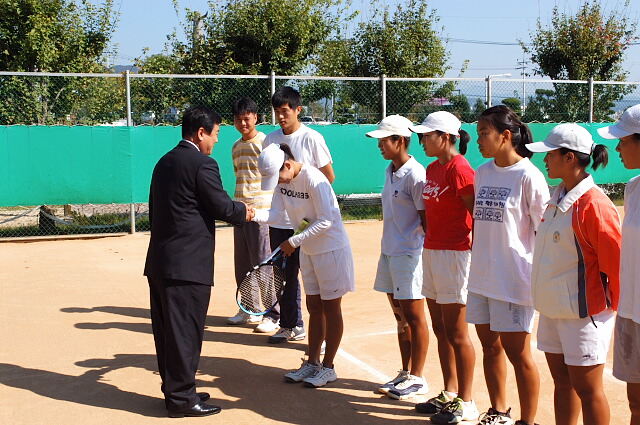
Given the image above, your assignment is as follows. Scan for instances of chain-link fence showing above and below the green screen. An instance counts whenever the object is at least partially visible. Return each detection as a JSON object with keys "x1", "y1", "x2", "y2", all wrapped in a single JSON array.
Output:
[{"x1": 0, "y1": 72, "x2": 640, "y2": 238}]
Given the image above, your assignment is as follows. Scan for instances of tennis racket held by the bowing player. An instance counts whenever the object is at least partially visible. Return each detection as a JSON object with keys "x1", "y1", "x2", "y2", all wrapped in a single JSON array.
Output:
[{"x1": 236, "y1": 220, "x2": 309, "y2": 316}]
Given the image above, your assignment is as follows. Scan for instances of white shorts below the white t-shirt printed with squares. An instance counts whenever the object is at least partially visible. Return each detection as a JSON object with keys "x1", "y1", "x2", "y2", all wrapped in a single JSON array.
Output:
[{"x1": 466, "y1": 292, "x2": 534, "y2": 333}]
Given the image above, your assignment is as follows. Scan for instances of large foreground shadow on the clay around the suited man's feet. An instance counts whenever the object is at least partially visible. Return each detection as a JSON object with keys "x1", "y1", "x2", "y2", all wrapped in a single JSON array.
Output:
[{"x1": 0, "y1": 354, "x2": 424, "y2": 425}]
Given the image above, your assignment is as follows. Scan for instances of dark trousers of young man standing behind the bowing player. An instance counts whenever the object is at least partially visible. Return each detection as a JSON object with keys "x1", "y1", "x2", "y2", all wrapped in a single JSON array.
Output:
[{"x1": 269, "y1": 227, "x2": 304, "y2": 328}]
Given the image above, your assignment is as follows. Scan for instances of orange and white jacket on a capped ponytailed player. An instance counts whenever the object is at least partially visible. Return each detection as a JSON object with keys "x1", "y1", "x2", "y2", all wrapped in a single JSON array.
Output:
[{"x1": 531, "y1": 176, "x2": 621, "y2": 319}]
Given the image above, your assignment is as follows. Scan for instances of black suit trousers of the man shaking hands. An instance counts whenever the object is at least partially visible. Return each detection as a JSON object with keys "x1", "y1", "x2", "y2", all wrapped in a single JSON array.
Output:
[{"x1": 147, "y1": 277, "x2": 211, "y2": 409}]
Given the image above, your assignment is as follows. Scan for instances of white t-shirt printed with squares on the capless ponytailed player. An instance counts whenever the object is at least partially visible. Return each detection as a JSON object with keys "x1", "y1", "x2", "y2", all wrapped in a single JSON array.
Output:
[{"x1": 468, "y1": 158, "x2": 549, "y2": 306}]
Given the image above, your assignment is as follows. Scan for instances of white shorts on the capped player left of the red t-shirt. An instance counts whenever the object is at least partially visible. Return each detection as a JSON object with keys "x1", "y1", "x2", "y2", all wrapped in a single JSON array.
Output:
[{"x1": 373, "y1": 254, "x2": 424, "y2": 300}]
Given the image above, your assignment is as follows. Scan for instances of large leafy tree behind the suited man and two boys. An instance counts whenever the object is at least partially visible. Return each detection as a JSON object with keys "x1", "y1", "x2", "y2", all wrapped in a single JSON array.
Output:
[{"x1": 165, "y1": 0, "x2": 344, "y2": 119}]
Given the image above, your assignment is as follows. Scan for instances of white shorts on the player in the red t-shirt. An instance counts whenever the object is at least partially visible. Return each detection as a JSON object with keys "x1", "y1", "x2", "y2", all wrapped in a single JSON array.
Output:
[{"x1": 422, "y1": 249, "x2": 471, "y2": 305}]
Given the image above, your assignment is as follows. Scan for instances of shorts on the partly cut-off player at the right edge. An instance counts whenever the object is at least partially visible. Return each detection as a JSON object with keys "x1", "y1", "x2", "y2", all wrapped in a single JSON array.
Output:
[{"x1": 613, "y1": 316, "x2": 640, "y2": 384}]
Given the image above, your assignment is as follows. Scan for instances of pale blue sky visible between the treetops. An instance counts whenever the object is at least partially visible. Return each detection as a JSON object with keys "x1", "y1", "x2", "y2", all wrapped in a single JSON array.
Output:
[{"x1": 112, "y1": 0, "x2": 640, "y2": 81}]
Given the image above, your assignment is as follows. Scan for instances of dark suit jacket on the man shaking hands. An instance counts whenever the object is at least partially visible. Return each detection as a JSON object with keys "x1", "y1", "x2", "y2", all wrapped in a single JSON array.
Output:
[{"x1": 144, "y1": 140, "x2": 246, "y2": 285}]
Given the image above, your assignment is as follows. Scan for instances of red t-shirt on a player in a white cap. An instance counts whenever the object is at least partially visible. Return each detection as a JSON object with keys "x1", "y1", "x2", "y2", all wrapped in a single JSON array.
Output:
[{"x1": 422, "y1": 155, "x2": 475, "y2": 251}]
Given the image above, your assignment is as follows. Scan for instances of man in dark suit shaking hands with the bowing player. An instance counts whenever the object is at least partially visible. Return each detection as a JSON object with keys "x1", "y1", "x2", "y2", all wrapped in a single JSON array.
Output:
[{"x1": 144, "y1": 106, "x2": 253, "y2": 417}]
